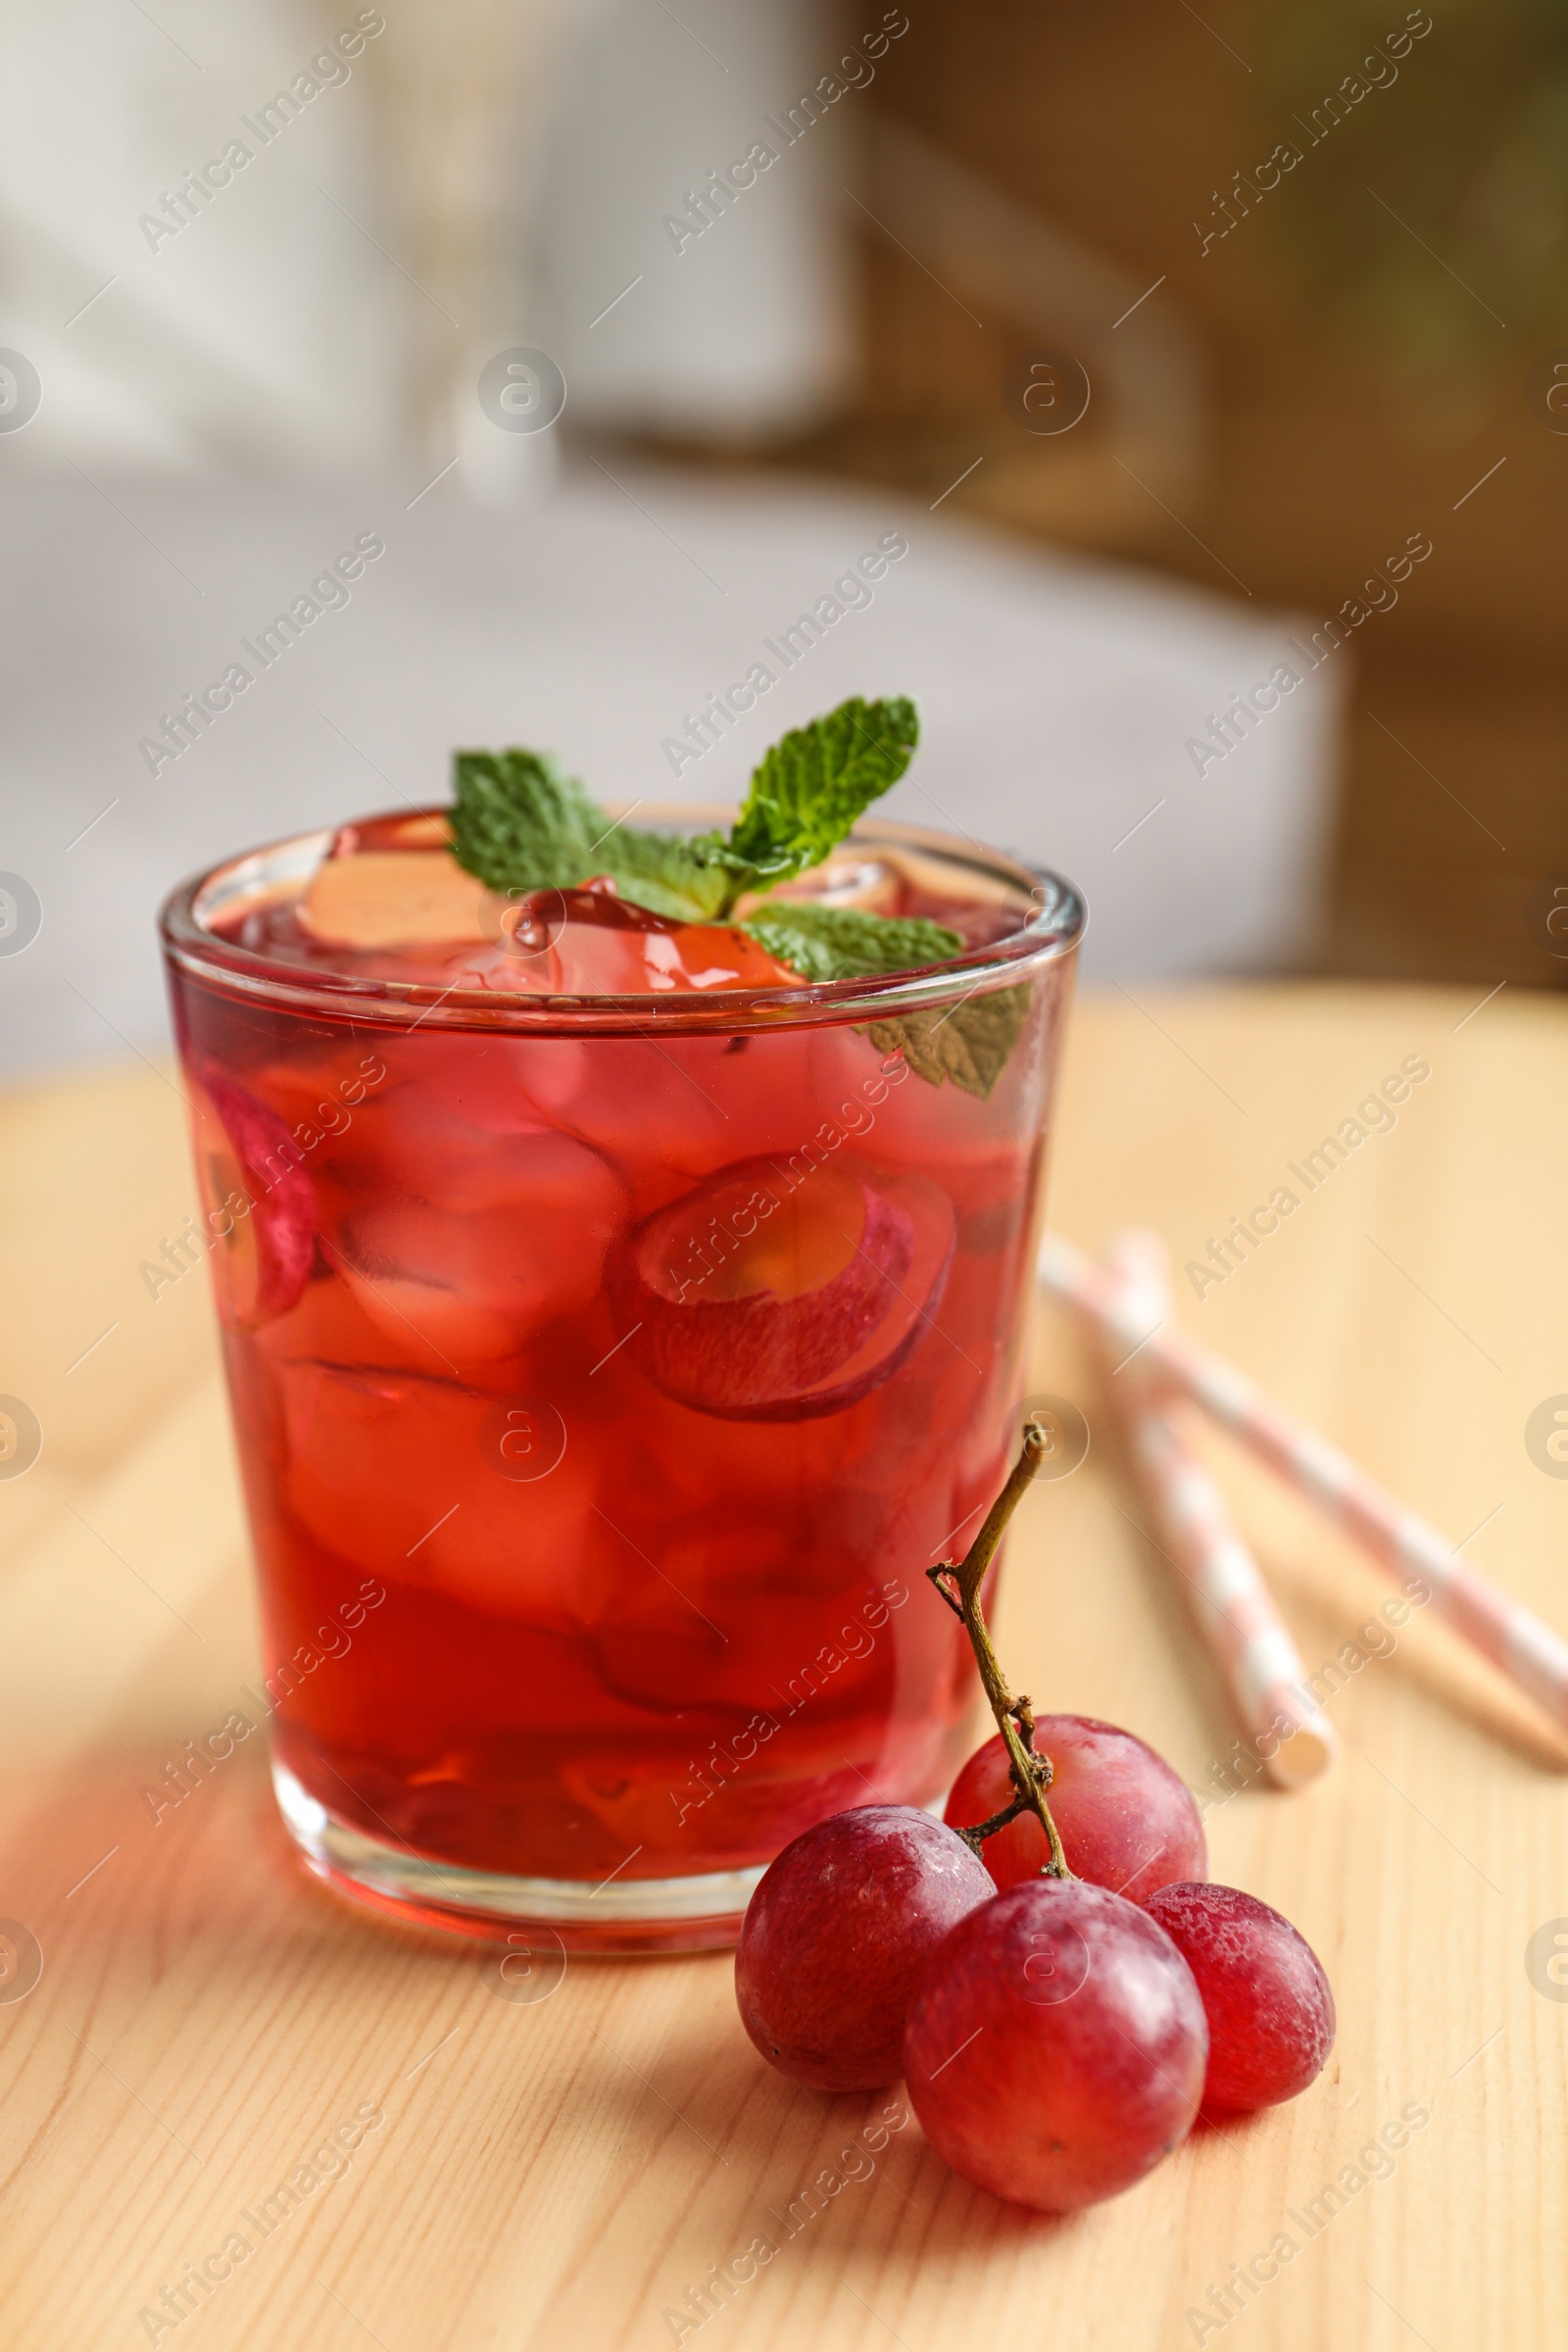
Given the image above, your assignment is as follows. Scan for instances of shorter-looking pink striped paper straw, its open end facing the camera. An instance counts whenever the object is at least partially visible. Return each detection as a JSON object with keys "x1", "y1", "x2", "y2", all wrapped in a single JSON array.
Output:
[{"x1": 1109, "y1": 1233, "x2": 1338, "y2": 1788}]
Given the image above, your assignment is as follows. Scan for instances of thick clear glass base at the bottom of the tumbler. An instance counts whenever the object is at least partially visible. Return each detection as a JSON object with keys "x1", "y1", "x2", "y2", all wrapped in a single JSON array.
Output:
[{"x1": 272, "y1": 1759, "x2": 766, "y2": 1952}]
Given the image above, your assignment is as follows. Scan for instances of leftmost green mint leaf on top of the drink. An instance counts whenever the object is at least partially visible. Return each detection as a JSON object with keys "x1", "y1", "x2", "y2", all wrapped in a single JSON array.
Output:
[{"x1": 452, "y1": 751, "x2": 729, "y2": 922}]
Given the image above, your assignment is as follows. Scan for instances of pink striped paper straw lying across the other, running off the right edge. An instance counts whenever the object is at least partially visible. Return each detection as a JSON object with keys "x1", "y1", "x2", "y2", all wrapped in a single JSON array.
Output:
[{"x1": 1039, "y1": 1235, "x2": 1568, "y2": 1727}]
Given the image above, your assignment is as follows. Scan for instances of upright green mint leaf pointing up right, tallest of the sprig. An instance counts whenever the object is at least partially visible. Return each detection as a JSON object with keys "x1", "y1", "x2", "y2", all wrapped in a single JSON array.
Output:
[{"x1": 696, "y1": 694, "x2": 919, "y2": 904}]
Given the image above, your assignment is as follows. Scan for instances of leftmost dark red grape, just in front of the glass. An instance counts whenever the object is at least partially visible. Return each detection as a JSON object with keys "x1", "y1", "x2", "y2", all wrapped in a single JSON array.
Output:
[{"x1": 736, "y1": 1804, "x2": 995, "y2": 2091}]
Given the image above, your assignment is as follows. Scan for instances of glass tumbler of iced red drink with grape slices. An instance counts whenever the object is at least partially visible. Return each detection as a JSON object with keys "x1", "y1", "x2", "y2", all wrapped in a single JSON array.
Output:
[{"x1": 165, "y1": 818, "x2": 1081, "y2": 1950}]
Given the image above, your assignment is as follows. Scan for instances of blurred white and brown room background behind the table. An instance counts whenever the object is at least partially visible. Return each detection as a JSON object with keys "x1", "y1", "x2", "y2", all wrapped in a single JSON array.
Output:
[{"x1": 0, "y1": 0, "x2": 1568, "y2": 1068}]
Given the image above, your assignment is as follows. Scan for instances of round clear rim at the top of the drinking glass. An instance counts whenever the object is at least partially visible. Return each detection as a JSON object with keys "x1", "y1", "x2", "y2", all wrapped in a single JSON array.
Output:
[{"x1": 158, "y1": 800, "x2": 1089, "y2": 1037}]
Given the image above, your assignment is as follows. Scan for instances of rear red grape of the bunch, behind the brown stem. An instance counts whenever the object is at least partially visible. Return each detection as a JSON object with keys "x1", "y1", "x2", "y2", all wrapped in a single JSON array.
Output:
[{"x1": 943, "y1": 1715, "x2": 1208, "y2": 1903}]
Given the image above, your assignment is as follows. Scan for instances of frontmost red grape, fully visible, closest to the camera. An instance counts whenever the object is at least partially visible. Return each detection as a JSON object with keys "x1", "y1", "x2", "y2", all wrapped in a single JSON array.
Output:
[{"x1": 903, "y1": 1880, "x2": 1208, "y2": 2213}]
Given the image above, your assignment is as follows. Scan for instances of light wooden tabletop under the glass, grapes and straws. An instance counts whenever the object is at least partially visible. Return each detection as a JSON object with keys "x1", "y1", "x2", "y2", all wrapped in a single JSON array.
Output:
[{"x1": 0, "y1": 988, "x2": 1568, "y2": 2352}]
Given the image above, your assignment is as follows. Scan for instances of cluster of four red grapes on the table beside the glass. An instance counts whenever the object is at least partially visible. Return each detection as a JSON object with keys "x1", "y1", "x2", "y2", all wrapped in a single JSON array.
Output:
[{"x1": 736, "y1": 1703, "x2": 1333, "y2": 2213}]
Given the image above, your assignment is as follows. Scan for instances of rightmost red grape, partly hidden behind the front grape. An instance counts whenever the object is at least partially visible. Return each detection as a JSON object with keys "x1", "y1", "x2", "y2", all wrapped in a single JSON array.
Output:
[{"x1": 1148, "y1": 1886, "x2": 1333, "y2": 2115}]
